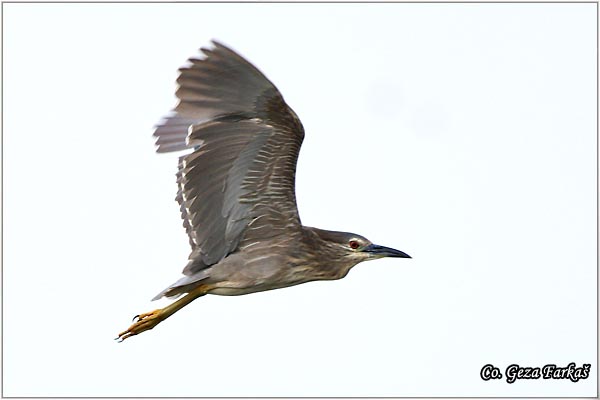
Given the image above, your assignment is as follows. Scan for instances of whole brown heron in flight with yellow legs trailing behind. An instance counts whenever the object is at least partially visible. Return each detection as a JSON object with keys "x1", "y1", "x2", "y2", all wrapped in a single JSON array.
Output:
[{"x1": 117, "y1": 42, "x2": 410, "y2": 340}]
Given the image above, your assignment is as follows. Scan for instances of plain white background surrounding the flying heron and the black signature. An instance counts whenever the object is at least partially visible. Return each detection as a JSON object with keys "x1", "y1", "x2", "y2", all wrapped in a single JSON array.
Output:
[{"x1": 3, "y1": 4, "x2": 597, "y2": 396}]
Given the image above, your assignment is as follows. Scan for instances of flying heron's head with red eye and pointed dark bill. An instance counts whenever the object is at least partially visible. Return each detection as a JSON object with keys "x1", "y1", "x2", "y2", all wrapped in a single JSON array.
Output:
[{"x1": 312, "y1": 228, "x2": 411, "y2": 264}]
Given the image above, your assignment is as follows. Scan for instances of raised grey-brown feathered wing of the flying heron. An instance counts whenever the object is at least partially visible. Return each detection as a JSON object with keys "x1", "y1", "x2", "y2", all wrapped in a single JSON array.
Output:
[{"x1": 154, "y1": 41, "x2": 304, "y2": 275}]
